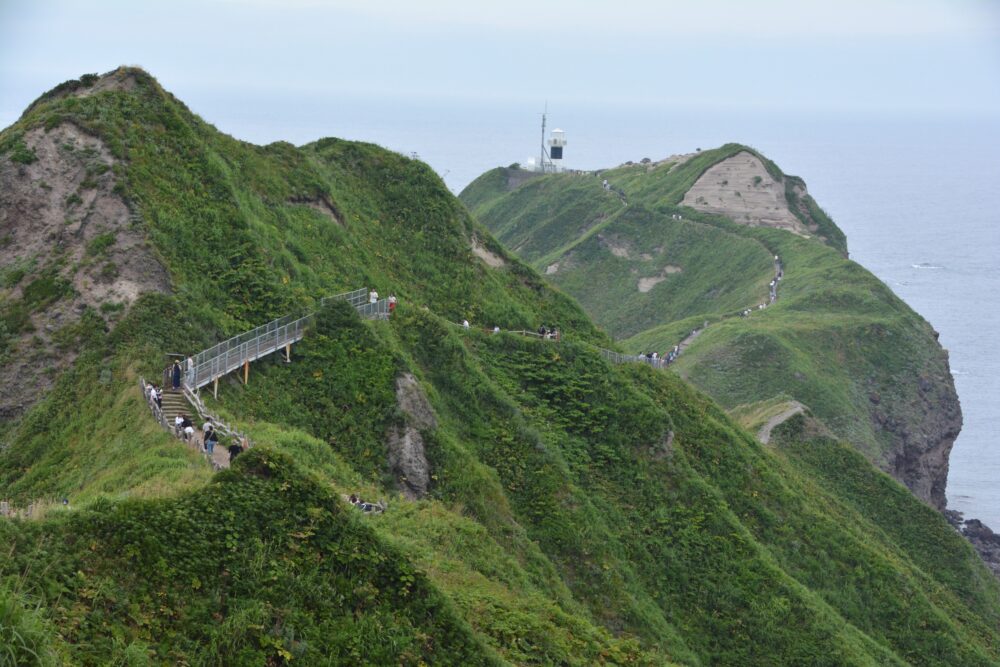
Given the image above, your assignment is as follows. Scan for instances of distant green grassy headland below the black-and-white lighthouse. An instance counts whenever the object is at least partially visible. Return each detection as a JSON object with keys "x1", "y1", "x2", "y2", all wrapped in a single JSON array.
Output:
[{"x1": 461, "y1": 144, "x2": 961, "y2": 508}]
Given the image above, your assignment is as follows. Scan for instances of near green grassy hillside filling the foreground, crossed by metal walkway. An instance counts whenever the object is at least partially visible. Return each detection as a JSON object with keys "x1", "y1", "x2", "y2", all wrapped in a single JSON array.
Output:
[{"x1": 0, "y1": 70, "x2": 1000, "y2": 665}]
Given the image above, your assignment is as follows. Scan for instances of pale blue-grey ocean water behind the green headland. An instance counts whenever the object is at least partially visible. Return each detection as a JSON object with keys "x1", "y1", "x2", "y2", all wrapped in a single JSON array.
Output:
[{"x1": 127, "y1": 92, "x2": 1000, "y2": 529}]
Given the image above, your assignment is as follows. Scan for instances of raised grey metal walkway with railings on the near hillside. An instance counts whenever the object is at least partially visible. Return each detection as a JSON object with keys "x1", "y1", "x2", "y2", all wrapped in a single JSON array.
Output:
[{"x1": 184, "y1": 287, "x2": 390, "y2": 391}]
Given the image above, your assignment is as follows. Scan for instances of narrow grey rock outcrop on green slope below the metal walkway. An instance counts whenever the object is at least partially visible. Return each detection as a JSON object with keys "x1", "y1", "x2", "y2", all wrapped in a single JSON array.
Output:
[{"x1": 386, "y1": 373, "x2": 437, "y2": 500}]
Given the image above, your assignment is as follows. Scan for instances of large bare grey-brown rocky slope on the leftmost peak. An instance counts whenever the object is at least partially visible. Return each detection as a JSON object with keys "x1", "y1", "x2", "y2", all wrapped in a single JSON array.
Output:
[{"x1": 0, "y1": 121, "x2": 170, "y2": 421}]
